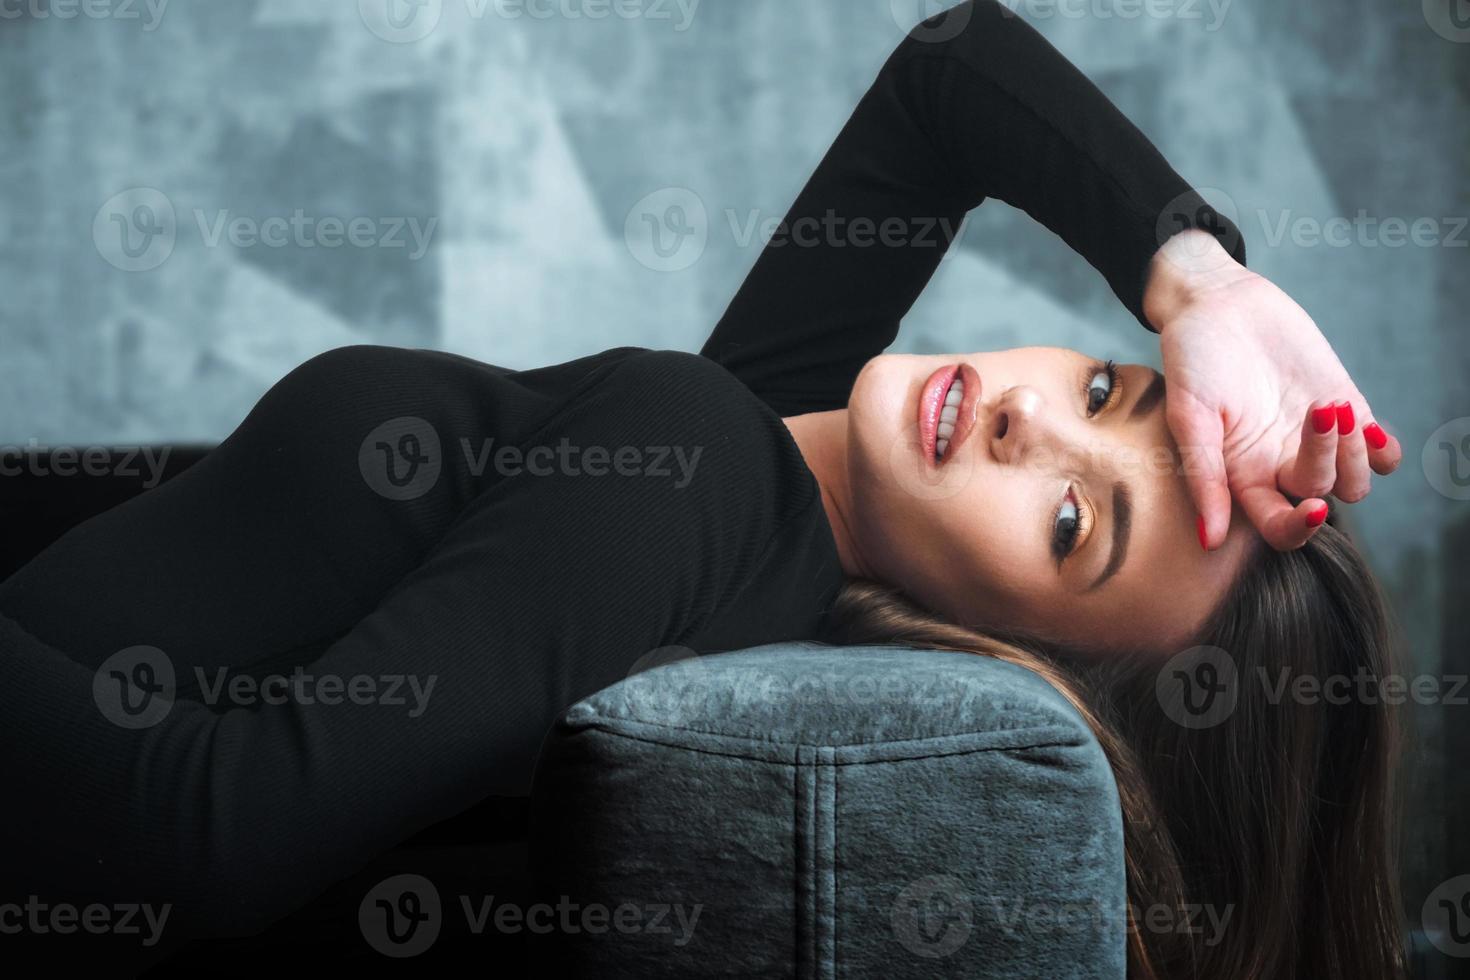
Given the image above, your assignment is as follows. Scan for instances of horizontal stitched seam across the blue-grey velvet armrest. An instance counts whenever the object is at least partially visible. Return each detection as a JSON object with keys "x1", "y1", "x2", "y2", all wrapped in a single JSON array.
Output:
[{"x1": 555, "y1": 721, "x2": 1089, "y2": 765}]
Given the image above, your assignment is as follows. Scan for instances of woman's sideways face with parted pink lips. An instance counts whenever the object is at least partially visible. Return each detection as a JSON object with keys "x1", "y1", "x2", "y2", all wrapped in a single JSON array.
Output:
[{"x1": 847, "y1": 347, "x2": 1258, "y2": 652}]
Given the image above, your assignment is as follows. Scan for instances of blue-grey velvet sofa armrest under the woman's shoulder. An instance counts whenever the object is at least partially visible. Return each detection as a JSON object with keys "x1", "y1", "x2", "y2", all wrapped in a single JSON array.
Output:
[{"x1": 529, "y1": 644, "x2": 1126, "y2": 980}]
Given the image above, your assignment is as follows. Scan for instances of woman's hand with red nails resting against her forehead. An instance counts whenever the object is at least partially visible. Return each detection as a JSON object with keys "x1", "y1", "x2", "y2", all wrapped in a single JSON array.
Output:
[{"x1": 1144, "y1": 231, "x2": 1402, "y2": 551}]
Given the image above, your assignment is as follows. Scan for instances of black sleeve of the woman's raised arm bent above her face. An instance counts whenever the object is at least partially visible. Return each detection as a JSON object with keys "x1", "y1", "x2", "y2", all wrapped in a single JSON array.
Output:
[{"x1": 703, "y1": 0, "x2": 1245, "y2": 414}]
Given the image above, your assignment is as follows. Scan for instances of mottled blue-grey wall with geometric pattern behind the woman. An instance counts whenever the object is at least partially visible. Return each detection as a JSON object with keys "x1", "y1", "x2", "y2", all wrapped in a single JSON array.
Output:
[{"x1": 0, "y1": 0, "x2": 1470, "y2": 963}]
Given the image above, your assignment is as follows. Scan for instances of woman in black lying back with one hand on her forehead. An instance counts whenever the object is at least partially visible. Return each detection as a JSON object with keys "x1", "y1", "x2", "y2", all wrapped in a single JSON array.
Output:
[{"x1": 0, "y1": 3, "x2": 1399, "y2": 977}]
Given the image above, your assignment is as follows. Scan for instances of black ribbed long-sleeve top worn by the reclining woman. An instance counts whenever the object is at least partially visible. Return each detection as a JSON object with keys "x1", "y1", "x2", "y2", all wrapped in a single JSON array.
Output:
[{"x1": 0, "y1": 1, "x2": 1244, "y2": 952}]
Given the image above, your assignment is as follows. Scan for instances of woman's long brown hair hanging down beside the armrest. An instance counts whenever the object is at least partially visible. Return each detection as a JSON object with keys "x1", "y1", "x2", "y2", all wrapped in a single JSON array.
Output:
[{"x1": 823, "y1": 514, "x2": 1405, "y2": 980}]
